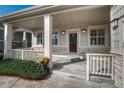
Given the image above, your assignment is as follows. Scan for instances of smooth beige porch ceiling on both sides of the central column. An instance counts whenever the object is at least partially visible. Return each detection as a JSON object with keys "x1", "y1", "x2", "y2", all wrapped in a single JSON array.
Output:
[{"x1": 13, "y1": 6, "x2": 110, "y2": 29}]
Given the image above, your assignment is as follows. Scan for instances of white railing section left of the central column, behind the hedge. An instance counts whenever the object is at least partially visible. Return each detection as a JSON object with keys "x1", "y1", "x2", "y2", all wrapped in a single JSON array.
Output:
[{"x1": 7, "y1": 49, "x2": 44, "y2": 61}]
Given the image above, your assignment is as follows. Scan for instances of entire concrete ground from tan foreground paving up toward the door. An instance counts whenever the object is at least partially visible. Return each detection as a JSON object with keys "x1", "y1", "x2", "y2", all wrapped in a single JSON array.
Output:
[{"x1": 0, "y1": 55, "x2": 115, "y2": 88}]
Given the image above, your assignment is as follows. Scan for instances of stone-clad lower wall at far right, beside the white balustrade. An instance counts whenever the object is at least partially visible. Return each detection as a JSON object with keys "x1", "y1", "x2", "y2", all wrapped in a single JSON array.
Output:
[{"x1": 113, "y1": 54, "x2": 123, "y2": 88}]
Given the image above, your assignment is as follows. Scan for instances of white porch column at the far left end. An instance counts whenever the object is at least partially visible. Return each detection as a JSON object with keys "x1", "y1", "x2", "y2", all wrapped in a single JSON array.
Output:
[{"x1": 3, "y1": 23, "x2": 13, "y2": 58}]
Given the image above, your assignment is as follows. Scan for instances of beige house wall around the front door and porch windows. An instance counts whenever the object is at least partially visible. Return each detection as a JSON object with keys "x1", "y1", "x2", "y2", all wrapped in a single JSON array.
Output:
[{"x1": 32, "y1": 25, "x2": 110, "y2": 55}]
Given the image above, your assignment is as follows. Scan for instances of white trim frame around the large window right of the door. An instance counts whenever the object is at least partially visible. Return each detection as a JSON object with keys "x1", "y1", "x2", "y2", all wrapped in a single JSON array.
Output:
[{"x1": 88, "y1": 25, "x2": 108, "y2": 48}]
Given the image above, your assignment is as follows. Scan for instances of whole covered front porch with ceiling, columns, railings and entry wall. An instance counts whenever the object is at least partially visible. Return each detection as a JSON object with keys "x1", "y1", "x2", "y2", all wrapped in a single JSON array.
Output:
[{"x1": 0, "y1": 6, "x2": 113, "y2": 81}]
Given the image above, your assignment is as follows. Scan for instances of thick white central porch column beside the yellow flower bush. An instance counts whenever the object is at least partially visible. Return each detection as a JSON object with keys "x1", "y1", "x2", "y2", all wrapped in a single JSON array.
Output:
[{"x1": 44, "y1": 15, "x2": 52, "y2": 68}]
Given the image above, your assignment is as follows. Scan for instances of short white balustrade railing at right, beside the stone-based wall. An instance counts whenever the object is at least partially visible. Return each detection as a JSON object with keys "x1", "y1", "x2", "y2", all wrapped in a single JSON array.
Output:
[{"x1": 86, "y1": 53, "x2": 114, "y2": 81}]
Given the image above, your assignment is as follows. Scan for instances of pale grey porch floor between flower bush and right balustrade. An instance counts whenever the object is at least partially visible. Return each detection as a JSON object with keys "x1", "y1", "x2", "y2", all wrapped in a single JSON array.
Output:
[{"x1": 53, "y1": 56, "x2": 115, "y2": 88}]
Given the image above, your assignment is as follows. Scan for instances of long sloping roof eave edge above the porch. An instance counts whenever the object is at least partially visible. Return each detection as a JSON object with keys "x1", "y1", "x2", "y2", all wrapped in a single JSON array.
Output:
[{"x1": 0, "y1": 5, "x2": 108, "y2": 22}]
